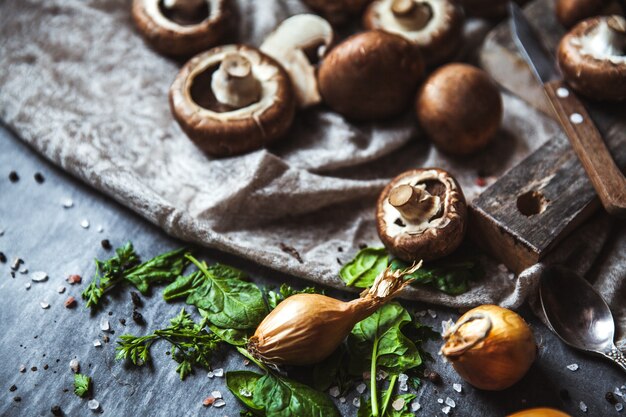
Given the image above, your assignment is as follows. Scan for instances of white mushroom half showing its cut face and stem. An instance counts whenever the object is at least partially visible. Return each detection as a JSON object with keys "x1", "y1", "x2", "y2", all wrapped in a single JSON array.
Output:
[{"x1": 260, "y1": 14, "x2": 333, "y2": 107}]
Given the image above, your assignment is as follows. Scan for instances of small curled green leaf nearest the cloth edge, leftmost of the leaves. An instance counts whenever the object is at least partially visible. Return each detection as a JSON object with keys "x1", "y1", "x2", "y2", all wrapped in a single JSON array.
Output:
[{"x1": 124, "y1": 248, "x2": 189, "y2": 294}]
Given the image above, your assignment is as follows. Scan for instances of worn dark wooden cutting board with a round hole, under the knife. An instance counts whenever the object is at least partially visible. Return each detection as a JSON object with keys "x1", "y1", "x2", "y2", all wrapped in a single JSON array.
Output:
[{"x1": 469, "y1": 0, "x2": 626, "y2": 273}]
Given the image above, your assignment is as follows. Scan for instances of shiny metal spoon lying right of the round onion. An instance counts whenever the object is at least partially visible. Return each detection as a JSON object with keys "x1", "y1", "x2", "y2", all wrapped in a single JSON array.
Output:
[{"x1": 539, "y1": 266, "x2": 626, "y2": 371}]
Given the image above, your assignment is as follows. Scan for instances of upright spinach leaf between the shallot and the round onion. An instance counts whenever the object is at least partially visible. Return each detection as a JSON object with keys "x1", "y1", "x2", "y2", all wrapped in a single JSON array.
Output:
[{"x1": 348, "y1": 303, "x2": 422, "y2": 375}]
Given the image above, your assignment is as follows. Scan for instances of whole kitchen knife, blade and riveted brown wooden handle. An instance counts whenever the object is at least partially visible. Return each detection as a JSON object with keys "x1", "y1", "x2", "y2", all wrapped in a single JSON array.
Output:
[{"x1": 509, "y1": 2, "x2": 626, "y2": 217}]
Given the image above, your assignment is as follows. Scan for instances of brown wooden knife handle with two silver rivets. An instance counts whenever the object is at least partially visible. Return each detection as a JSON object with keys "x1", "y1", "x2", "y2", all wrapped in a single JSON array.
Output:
[{"x1": 544, "y1": 81, "x2": 626, "y2": 217}]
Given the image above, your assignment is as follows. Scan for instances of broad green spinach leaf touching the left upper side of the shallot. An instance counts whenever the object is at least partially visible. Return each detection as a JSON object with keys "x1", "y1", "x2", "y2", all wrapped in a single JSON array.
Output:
[{"x1": 182, "y1": 255, "x2": 267, "y2": 330}]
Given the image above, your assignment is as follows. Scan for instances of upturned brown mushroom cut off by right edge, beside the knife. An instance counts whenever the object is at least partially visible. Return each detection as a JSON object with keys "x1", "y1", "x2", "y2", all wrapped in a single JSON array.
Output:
[{"x1": 557, "y1": 15, "x2": 626, "y2": 101}]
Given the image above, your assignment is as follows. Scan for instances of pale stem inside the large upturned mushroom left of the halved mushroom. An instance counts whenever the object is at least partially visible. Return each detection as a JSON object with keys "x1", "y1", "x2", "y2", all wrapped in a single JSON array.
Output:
[{"x1": 211, "y1": 53, "x2": 261, "y2": 109}]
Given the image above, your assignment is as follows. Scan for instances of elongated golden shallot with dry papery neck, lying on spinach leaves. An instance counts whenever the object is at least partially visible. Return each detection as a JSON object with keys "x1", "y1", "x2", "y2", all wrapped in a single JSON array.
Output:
[{"x1": 248, "y1": 262, "x2": 421, "y2": 365}]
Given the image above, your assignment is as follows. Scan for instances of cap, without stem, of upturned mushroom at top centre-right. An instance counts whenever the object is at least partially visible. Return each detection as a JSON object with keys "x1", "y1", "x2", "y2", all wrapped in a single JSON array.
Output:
[{"x1": 363, "y1": 0, "x2": 464, "y2": 66}]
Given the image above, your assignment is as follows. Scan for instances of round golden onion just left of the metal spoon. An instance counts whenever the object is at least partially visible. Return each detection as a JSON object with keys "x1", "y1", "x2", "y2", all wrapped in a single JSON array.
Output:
[{"x1": 441, "y1": 305, "x2": 537, "y2": 391}]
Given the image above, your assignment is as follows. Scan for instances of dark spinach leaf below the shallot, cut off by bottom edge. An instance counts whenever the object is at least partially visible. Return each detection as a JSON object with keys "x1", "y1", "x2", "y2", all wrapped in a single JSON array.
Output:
[{"x1": 254, "y1": 374, "x2": 340, "y2": 417}]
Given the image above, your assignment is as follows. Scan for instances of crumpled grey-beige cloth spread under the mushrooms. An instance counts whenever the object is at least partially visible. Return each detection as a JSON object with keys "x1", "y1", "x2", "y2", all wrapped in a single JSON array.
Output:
[{"x1": 0, "y1": 0, "x2": 624, "y2": 316}]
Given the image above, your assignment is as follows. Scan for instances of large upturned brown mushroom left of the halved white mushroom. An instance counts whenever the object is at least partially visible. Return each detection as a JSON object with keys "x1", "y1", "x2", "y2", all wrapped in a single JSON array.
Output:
[{"x1": 170, "y1": 45, "x2": 295, "y2": 156}]
